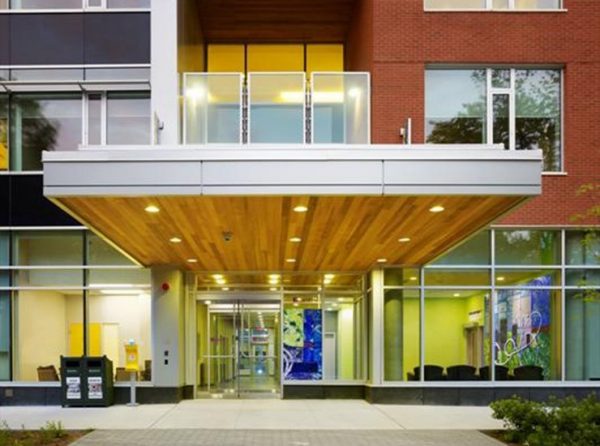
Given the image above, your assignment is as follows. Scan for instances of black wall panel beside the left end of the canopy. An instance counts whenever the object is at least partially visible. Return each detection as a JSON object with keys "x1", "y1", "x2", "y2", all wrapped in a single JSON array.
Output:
[{"x1": 9, "y1": 174, "x2": 81, "y2": 226}]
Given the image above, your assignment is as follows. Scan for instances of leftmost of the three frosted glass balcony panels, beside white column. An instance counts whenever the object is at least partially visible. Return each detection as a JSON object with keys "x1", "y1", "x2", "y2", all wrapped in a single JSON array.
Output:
[{"x1": 184, "y1": 73, "x2": 242, "y2": 144}]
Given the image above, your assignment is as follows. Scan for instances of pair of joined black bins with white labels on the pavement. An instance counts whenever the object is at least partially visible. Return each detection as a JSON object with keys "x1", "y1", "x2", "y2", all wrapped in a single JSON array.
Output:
[{"x1": 60, "y1": 356, "x2": 114, "y2": 407}]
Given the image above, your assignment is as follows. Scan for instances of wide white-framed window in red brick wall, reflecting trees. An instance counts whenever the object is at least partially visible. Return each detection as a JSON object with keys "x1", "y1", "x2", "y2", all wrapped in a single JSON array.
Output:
[{"x1": 425, "y1": 68, "x2": 562, "y2": 171}]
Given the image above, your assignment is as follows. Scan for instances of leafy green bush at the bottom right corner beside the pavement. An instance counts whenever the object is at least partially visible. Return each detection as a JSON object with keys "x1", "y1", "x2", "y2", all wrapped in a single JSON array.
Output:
[{"x1": 490, "y1": 395, "x2": 600, "y2": 446}]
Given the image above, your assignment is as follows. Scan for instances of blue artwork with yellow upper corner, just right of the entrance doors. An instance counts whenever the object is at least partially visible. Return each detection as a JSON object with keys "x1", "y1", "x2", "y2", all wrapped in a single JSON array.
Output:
[{"x1": 283, "y1": 308, "x2": 323, "y2": 380}]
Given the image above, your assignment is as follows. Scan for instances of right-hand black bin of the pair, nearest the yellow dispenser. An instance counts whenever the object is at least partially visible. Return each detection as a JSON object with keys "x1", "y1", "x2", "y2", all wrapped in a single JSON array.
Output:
[{"x1": 84, "y1": 356, "x2": 114, "y2": 407}]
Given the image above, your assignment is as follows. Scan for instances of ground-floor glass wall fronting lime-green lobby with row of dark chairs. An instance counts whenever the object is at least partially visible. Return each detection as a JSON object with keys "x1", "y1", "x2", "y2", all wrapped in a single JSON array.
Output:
[{"x1": 383, "y1": 229, "x2": 600, "y2": 381}]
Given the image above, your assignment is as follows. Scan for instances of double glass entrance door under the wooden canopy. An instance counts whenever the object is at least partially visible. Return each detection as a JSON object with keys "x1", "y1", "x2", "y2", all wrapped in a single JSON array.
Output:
[{"x1": 200, "y1": 300, "x2": 281, "y2": 398}]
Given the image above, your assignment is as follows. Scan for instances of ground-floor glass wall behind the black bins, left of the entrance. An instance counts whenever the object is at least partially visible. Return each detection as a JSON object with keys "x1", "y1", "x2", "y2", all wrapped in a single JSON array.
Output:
[{"x1": 0, "y1": 229, "x2": 151, "y2": 381}]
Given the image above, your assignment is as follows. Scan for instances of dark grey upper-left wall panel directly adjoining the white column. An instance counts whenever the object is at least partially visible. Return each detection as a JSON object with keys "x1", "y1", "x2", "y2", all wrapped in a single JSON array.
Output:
[{"x1": 84, "y1": 12, "x2": 150, "y2": 64}]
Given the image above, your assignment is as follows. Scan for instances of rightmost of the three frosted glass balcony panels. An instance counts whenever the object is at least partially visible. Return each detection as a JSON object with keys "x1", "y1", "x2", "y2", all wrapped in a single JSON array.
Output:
[{"x1": 312, "y1": 73, "x2": 370, "y2": 144}]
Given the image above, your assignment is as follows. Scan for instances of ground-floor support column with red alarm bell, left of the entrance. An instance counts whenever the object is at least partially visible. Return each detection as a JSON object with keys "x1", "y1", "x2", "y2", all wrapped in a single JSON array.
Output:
[{"x1": 152, "y1": 266, "x2": 185, "y2": 387}]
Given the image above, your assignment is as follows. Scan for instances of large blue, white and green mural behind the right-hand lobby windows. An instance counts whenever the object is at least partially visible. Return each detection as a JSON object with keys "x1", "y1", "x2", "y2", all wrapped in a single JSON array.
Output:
[{"x1": 494, "y1": 276, "x2": 552, "y2": 379}]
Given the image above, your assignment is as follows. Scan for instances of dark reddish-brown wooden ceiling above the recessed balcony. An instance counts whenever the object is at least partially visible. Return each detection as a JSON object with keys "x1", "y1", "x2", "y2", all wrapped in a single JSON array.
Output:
[{"x1": 198, "y1": 0, "x2": 356, "y2": 43}]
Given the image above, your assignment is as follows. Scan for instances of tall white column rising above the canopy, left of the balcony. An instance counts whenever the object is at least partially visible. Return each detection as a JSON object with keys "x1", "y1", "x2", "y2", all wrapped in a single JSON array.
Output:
[{"x1": 151, "y1": 0, "x2": 179, "y2": 145}]
